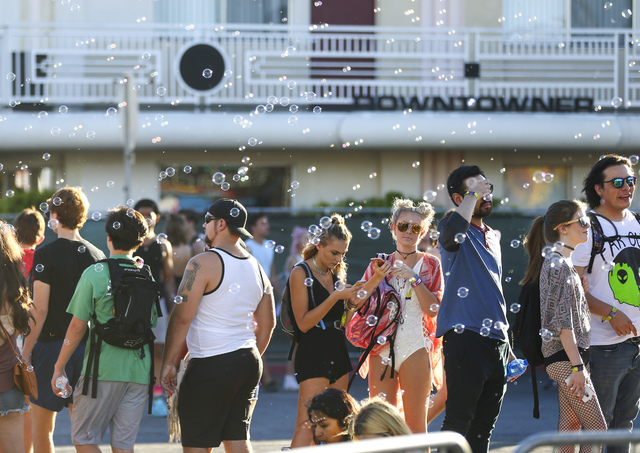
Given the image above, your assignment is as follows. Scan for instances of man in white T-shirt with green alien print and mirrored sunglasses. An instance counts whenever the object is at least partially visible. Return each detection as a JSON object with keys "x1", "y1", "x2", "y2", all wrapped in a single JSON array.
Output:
[{"x1": 572, "y1": 154, "x2": 640, "y2": 453}]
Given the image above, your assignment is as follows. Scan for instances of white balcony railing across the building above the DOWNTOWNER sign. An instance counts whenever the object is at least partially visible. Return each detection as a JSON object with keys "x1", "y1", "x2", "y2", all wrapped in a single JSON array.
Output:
[{"x1": 0, "y1": 23, "x2": 640, "y2": 108}]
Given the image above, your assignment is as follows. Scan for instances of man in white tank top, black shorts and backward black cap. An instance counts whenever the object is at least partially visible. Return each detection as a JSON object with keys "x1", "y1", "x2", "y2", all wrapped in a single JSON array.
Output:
[{"x1": 161, "y1": 198, "x2": 276, "y2": 453}]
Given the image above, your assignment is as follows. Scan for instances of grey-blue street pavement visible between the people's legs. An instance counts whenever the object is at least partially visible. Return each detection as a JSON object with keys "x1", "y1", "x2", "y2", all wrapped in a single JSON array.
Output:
[{"x1": 54, "y1": 362, "x2": 558, "y2": 453}]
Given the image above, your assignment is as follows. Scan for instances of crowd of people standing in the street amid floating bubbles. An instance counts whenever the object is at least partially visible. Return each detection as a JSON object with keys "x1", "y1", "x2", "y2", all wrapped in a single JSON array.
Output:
[{"x1": 0, "y1": 154, "x2": 640, "y2": 453}]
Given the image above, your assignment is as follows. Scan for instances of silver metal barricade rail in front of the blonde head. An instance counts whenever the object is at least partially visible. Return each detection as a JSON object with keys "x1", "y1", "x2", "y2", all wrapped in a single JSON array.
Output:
[{"x1": 264, "y1": 431, "x2": 471, "y2": 453}]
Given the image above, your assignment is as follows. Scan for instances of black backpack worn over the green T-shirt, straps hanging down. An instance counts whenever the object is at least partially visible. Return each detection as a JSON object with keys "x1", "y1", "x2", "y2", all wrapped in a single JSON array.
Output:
[{"x1": 82, "y1": 258, "x2": 162, "y2": 413}]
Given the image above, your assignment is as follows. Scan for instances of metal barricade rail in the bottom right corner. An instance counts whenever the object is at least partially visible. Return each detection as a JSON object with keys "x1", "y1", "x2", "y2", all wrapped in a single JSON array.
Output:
[{"x1": 513, "y1": 430, "x2": 640, "y2": 453}]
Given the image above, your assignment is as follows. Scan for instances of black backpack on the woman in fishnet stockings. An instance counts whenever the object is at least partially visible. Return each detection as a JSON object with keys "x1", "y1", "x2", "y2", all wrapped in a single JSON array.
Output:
[{"x1": 513, "y1": 280, "x2": 544, "y2": 418}]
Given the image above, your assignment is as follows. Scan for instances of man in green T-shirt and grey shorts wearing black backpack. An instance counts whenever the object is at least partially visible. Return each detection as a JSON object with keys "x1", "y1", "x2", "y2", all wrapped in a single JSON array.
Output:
[{"x1": 51, "y1": 207, "x2": 159, "y2": 451}]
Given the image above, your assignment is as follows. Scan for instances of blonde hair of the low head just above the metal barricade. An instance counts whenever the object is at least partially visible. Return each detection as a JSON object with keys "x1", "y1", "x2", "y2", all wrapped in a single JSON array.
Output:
[{"x1": 350, "y1": 397, "x2": 411, "y2": 439}]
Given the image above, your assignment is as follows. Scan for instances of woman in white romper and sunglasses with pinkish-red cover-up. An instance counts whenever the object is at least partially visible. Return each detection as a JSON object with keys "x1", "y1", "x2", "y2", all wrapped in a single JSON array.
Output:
[{"x1": 363, "y1": 199, "x2": 444, "y2": 433}]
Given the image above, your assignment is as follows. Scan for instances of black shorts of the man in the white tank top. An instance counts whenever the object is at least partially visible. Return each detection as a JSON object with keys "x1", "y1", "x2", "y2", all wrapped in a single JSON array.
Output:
[{"x1": 178, "y1": 347, "x2": 262, "y2": 448}]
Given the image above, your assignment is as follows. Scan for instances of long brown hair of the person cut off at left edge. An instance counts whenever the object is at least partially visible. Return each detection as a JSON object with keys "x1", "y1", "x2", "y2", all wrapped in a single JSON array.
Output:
[{"x1": 0, "y1": 221, "x2": 31, "y2": 335}]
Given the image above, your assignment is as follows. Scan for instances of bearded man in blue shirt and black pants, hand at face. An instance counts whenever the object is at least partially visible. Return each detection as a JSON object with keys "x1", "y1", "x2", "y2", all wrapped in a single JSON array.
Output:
[{"x1": 436, "y1": 165, "x2": 512, "y2": 453}]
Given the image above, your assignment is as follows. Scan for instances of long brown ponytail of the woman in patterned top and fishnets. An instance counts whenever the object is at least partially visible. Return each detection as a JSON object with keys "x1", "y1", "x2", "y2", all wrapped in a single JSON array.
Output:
[{"x1": 520, "y1": 200, "x2": 586, "y2": 285}]
